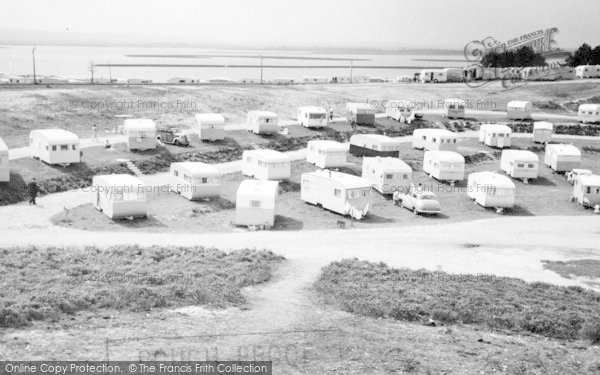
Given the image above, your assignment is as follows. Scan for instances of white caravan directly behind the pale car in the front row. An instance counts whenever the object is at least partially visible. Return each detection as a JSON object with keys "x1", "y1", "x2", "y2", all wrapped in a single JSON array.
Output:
[{"x1": 362, "y1": 156, "x2": 412, "y2": 194}]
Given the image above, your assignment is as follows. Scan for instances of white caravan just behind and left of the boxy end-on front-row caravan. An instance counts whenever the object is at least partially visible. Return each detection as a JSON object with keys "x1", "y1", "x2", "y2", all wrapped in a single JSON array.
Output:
[{"x1": 170, "y1": 162, "x2": 221, "y2": 201}]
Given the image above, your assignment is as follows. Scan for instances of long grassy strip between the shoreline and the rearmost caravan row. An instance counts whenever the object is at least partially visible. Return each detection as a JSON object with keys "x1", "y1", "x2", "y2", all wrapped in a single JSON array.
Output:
[{"x1": 0, "y1": 81, "x2": 600, "y2": 147}]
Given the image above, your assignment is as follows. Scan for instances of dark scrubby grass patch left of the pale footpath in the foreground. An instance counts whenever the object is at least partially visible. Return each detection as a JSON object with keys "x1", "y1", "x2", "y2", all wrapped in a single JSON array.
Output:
[{"x1": 0, "y1": 246, "x2": 283, "y2": 328}]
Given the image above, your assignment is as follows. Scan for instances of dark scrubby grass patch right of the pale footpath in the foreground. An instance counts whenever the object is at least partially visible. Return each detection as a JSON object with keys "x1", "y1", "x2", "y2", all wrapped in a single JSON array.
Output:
[{"x1": 315, "y1": 259, "x2": 600, "y2": 344}]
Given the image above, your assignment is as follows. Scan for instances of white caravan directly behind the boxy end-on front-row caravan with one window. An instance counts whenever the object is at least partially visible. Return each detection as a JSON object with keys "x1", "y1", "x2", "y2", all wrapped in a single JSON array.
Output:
[{"x1": 242, "y1": 150, "x2": 291, "y2": 180}]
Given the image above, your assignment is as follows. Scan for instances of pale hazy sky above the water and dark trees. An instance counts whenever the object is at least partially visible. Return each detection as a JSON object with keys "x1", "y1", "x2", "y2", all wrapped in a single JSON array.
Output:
[{"x1": 0, "y1": 0, "x2": 600, "y2": 48}]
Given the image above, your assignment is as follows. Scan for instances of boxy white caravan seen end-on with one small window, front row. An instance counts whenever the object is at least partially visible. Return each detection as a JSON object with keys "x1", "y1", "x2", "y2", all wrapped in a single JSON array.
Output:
[{"x1": 235, "y1": 180, "x2": 279, "y2": 228}]
